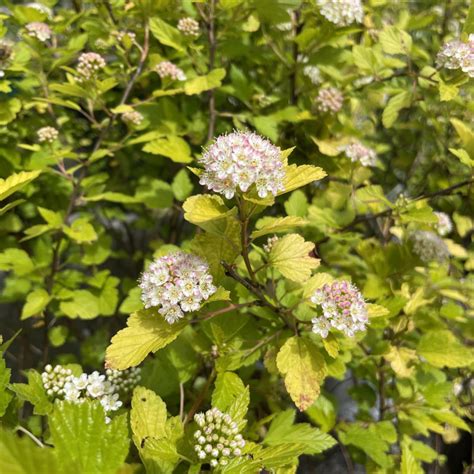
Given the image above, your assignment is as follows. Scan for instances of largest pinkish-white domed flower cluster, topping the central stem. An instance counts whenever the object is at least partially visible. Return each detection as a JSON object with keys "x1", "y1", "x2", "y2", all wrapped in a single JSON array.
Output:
[{"x1": 199, "y1": 132, "x2": 285, "y2": 199}]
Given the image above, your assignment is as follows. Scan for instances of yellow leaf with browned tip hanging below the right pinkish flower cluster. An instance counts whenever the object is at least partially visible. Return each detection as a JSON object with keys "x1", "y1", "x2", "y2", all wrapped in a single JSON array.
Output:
[{"x1": 276, "y1": 336, "x2": 327, "y2": 411}]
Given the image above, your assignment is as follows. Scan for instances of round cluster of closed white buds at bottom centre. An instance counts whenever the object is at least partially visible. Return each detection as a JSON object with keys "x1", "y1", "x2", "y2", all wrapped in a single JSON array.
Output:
[{"x1": 194, "y1": 408, "x2": 245, "y2": 467}]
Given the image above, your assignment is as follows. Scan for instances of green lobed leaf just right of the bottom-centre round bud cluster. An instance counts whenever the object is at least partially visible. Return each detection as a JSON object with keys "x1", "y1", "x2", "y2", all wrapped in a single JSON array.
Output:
[{"x1": 263, "y1": 410, "x2": 336, "y2": 454}]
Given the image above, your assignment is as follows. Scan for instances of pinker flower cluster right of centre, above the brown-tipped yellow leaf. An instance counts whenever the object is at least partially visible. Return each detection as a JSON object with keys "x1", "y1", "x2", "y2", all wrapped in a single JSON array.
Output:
[{"x1": 311, "y1": 281, "x2": 369, "y2": 338}]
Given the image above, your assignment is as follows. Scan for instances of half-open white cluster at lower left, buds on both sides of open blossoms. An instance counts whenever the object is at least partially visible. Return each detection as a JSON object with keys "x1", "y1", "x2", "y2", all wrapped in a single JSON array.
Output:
[{"x1": 41, "y1": 364, "x2": 140, "y2": 420}]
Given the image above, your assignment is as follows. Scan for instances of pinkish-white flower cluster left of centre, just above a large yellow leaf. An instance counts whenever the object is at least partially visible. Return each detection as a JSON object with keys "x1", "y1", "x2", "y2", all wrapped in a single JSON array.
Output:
[{"x1": 139, "y1": 251, "x2": 217, "y2": 324}]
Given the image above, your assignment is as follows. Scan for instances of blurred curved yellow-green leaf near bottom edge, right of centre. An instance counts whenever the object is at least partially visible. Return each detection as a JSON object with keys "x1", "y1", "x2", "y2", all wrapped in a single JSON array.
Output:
[{"x1": 339, "y1": 423, "x2": 390, "y2": 468}]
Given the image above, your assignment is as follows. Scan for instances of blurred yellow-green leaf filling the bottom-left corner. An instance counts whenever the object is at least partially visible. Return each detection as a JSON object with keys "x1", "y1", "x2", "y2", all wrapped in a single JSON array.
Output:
[{"x1": 0, "y1": 429, "x2": 61, "y2": 474}]
